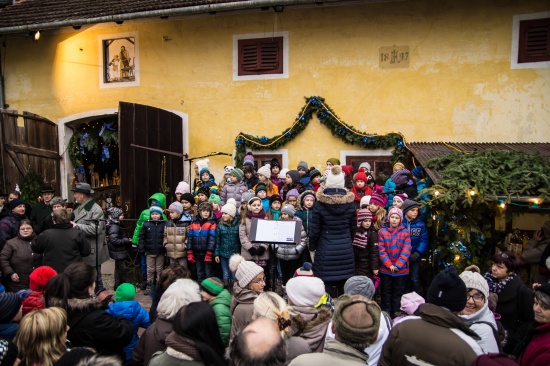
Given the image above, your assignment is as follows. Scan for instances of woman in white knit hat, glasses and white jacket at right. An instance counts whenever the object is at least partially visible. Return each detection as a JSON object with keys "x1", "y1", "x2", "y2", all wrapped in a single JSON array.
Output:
[{"x1": 459, "y1": 266, "x2": 500, "y2": 353}]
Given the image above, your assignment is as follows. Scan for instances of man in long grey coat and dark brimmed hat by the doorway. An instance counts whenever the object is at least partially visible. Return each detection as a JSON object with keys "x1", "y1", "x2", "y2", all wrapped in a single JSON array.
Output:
[{"x1": 72, "y1": 183, "x2": 109, "y2": 292}]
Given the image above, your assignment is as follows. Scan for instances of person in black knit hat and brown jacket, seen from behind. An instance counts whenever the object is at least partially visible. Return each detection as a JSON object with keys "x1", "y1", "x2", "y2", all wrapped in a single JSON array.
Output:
[{"x1": 378, "y1": 266, "x2": 483, "y2": 366}]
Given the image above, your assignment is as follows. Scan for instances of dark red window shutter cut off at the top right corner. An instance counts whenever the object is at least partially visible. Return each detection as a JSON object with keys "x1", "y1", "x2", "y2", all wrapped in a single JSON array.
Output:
[{"x1": 518, "y1": 18, "x2": 550, "y2": 63}]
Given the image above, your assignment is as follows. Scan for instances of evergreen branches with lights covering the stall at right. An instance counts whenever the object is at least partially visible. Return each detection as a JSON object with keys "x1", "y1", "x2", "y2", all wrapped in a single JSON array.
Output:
[{"x1": 421, "y1": 150, "x2": 550, "y2": 271}]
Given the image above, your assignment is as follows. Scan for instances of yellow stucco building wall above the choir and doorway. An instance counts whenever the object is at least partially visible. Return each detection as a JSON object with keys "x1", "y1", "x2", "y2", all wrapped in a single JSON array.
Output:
[{"x1": 5, "y1": 0, "x2": 550, "y2": 177}]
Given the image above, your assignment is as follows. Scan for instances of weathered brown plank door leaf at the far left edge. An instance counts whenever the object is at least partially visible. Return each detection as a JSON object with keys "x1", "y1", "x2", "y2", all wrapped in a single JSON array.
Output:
[{"x1": 0, "y1": 109, "x2": 61, "y2": 194}]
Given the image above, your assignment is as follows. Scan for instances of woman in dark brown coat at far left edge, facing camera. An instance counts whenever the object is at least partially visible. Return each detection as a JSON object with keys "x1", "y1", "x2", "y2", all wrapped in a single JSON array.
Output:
[{"x1": 0, "y1": 219, "x2": 42, "y2": 292}]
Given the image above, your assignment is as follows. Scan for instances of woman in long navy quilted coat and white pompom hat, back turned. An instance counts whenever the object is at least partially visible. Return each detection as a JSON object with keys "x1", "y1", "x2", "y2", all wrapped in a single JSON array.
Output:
[{"x1": 309, "y1": 166, "x2": 357, "y2": 298}]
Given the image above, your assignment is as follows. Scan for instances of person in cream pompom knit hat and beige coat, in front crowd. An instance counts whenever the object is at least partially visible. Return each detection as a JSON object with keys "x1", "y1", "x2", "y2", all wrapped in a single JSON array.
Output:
[{"x1": 229, "y1": 254, "x2": 265, "y2": 343}]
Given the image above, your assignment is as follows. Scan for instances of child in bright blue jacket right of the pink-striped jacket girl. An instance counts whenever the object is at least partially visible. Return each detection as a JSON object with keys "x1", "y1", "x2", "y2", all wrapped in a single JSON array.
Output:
[{"x1": 401, "y1": 199, "x2": 428, "y2": 292}]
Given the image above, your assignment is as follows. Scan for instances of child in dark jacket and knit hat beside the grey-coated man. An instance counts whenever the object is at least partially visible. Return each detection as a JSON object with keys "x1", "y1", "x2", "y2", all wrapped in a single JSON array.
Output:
[{"x1": 107, "y1": 207, "x2": 131, "y2": 290}]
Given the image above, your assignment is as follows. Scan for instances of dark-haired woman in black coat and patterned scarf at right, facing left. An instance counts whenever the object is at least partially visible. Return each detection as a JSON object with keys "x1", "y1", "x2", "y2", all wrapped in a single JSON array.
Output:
[{"x1": 485, "y1": 251, "x2": 534, "y2": 353}]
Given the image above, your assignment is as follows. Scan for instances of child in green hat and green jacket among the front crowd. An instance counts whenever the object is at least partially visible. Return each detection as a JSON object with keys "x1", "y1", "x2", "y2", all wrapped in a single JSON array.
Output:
[{"x1": 200, "y1": 277, "x2": 232, "y2": 347}]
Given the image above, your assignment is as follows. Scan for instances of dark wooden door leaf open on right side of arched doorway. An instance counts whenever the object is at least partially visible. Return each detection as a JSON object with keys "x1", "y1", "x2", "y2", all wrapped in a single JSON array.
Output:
[{"x1": 118, "y1": 102, "x2": 184, "y2": 219}]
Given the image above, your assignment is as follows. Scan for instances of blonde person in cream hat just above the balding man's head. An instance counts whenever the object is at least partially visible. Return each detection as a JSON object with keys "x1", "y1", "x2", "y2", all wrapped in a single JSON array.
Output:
[{"x1": 252, "y1": 291, "x2": 311, "y2": 364}]
